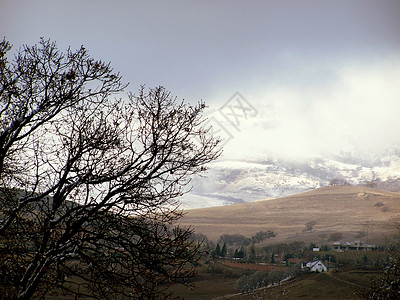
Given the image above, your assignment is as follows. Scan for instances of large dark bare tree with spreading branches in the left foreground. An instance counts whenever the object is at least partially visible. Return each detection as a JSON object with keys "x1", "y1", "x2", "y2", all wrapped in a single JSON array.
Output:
[{"x1": 0, "y1": 39, "x2": 220, "y2": 299}]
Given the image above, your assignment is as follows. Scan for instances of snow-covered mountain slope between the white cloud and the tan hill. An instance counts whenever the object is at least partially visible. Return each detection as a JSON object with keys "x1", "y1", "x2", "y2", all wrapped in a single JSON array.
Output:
[{"x1": 181, "y1": 151, "x2": 400, "y2": 209}]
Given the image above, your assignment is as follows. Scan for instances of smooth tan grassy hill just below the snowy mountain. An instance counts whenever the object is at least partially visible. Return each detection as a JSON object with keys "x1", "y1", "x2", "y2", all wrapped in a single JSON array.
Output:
[{"x1": 180, "y1": 186, "x2": 400, "y2": 244}]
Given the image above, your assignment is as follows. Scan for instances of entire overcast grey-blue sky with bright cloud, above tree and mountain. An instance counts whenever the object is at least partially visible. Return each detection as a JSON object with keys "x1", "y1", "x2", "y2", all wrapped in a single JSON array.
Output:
[{"x1": 0, "y1": 0, "x2": 400, "y2": 159}]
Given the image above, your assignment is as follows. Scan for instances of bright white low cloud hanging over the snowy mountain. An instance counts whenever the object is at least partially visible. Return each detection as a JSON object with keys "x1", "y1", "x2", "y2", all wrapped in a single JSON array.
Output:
[{"x1": 209, "y1": 58, "x2": 400, "y2": 163}]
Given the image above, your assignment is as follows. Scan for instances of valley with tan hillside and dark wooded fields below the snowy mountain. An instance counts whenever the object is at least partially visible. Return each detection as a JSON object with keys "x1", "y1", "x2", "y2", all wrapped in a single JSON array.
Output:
[{"x1": 173, "y1": 185, "x2": 400, "y2": 299}]
